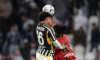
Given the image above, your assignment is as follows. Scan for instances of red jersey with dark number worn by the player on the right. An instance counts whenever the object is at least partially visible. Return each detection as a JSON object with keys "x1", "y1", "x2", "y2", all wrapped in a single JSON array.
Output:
[{"x1": 53, "y1": 35, "x2": 76, "y2": 60}]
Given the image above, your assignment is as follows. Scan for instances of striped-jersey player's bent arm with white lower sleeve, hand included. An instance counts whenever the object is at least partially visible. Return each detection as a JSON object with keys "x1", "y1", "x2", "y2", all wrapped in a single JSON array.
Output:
[{"x1": 48, "y1": 29, "x2": 65, "y2": 49}]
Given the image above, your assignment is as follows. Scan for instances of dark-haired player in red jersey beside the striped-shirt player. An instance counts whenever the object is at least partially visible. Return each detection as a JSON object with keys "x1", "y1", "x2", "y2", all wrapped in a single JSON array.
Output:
[{"x1": 53, "y1": 25, "x2": 76, "y2": 60}]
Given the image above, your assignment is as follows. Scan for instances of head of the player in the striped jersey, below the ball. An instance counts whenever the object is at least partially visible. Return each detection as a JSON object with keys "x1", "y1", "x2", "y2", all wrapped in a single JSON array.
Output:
[{"x1": 38, "y1": 12, "x2": 52, "y2": 25}]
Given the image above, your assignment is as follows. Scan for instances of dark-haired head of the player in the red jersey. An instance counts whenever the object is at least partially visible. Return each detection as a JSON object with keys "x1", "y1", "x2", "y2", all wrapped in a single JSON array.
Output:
[{"x1": 53, "y1": 25, "x2": 67, "y2": 37}]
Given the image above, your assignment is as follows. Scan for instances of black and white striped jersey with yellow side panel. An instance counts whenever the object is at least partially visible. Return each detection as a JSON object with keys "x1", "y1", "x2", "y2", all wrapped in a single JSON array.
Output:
[{"x1": 36, "y1": 23, "x2": 56, "y2": 56}]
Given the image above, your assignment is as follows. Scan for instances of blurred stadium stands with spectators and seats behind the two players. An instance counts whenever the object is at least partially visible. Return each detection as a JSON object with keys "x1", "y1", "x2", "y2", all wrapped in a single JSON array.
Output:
[{"x1": 0, "y1": 0, "x2": 100, "y2": 60}]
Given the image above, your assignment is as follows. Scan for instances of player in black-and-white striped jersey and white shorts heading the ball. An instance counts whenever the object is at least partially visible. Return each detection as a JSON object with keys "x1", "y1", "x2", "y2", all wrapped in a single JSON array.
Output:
[{"x1": 36, "y1": 12, "x2": 65, "y2": 60}]
